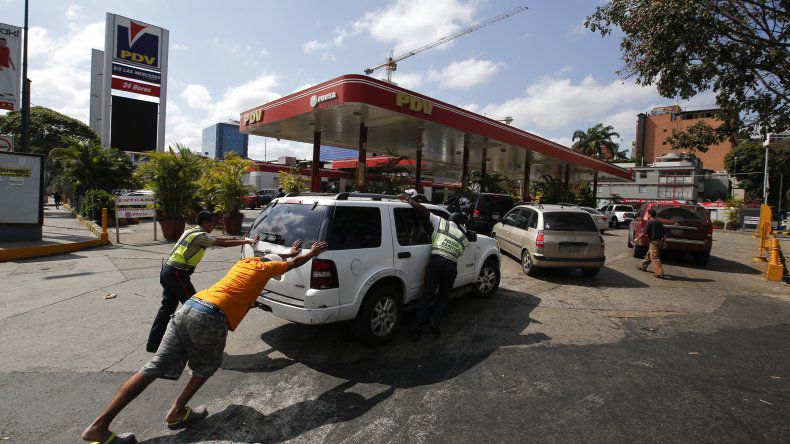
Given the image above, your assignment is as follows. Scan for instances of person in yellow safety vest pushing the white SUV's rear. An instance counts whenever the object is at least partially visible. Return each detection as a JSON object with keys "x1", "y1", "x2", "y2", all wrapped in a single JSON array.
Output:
[{"x1": 145, "y1": 211, "x2": 258, "y2": 353}]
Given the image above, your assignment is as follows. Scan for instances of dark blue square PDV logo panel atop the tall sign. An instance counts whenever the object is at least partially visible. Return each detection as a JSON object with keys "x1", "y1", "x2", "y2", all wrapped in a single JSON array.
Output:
[{"x1": 115, "y1": 17, "x2": 161, "y2": 68}]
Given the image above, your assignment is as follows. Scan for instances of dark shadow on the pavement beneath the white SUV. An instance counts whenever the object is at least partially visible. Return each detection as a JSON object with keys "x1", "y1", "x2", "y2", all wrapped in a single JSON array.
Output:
[{"x1": 223, "y1": 290, "x2": 551, "y2": 388}]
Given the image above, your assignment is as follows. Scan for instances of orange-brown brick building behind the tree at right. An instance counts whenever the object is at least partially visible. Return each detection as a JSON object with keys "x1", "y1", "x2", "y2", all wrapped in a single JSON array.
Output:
[{"x1": 634, "y1": 105, "x2": 733, "y2": 171}]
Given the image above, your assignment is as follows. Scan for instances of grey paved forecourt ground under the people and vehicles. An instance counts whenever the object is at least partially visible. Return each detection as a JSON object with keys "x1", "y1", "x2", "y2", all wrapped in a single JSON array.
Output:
[{"x1": 0, "y1": 212, "x2": 790, "y2": 442}]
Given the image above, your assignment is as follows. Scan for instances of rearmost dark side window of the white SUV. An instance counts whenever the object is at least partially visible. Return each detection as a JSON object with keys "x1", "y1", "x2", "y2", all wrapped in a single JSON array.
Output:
[{"x1": 326, "y1": 206, "x2": 381, "y2": 250}]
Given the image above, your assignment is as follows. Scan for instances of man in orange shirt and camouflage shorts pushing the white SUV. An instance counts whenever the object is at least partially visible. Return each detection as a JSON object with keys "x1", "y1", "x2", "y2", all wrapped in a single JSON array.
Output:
[{"x1": 82, "y1": 241, "x2": 326, "y2": 444}]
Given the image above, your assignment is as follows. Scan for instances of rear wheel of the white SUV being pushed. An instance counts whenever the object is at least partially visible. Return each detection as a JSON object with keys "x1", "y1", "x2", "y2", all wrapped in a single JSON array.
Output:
[{"x1": 352, "y1": 285, "x2": 403, "y2": 345}]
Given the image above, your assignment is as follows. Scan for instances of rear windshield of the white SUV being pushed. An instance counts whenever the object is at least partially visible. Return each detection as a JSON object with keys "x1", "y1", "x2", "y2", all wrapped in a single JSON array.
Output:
[{"x1": 248, "y1": 204, "x2": 328, "y2": 248}]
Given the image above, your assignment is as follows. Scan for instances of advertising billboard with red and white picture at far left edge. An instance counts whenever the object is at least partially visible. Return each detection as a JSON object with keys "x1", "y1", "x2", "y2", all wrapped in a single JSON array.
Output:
[{"x1": 0, "y1": 23, "x2": 22, "y2": 111}]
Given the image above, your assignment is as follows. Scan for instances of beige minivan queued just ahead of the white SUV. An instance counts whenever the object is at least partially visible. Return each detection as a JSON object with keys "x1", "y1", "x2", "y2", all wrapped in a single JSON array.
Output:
[{"x1": 493, "y1": 205, "x2": 606, "y2": 276}]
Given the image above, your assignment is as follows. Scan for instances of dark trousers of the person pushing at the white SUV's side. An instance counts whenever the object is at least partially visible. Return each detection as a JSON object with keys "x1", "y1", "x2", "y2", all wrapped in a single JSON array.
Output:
[{"x1": 414, "y1": 254, "x2": 458, "y2": 335}]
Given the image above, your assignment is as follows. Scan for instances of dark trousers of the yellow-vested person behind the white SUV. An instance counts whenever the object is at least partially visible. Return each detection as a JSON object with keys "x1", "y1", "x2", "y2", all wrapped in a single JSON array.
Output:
[{"x1": 145, "y1": 265, "x2": 197, "y2": 353}]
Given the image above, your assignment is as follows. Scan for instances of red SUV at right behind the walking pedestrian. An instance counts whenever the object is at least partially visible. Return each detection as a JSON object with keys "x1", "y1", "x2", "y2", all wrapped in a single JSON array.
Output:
[{"x1": 628, "y1": 203, "x2": 713, "y2": 265}]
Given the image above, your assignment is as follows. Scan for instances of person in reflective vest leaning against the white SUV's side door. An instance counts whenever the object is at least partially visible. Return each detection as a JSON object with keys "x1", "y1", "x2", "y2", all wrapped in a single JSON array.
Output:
[{"x1": 398, "y1": 194, "x2": 471, "y2": 342}]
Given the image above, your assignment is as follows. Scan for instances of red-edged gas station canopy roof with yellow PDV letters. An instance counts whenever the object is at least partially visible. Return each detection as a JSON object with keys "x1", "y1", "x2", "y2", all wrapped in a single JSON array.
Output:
[{"x1": 240, "y1": 74, "x2": 631, "y2": 182}]
